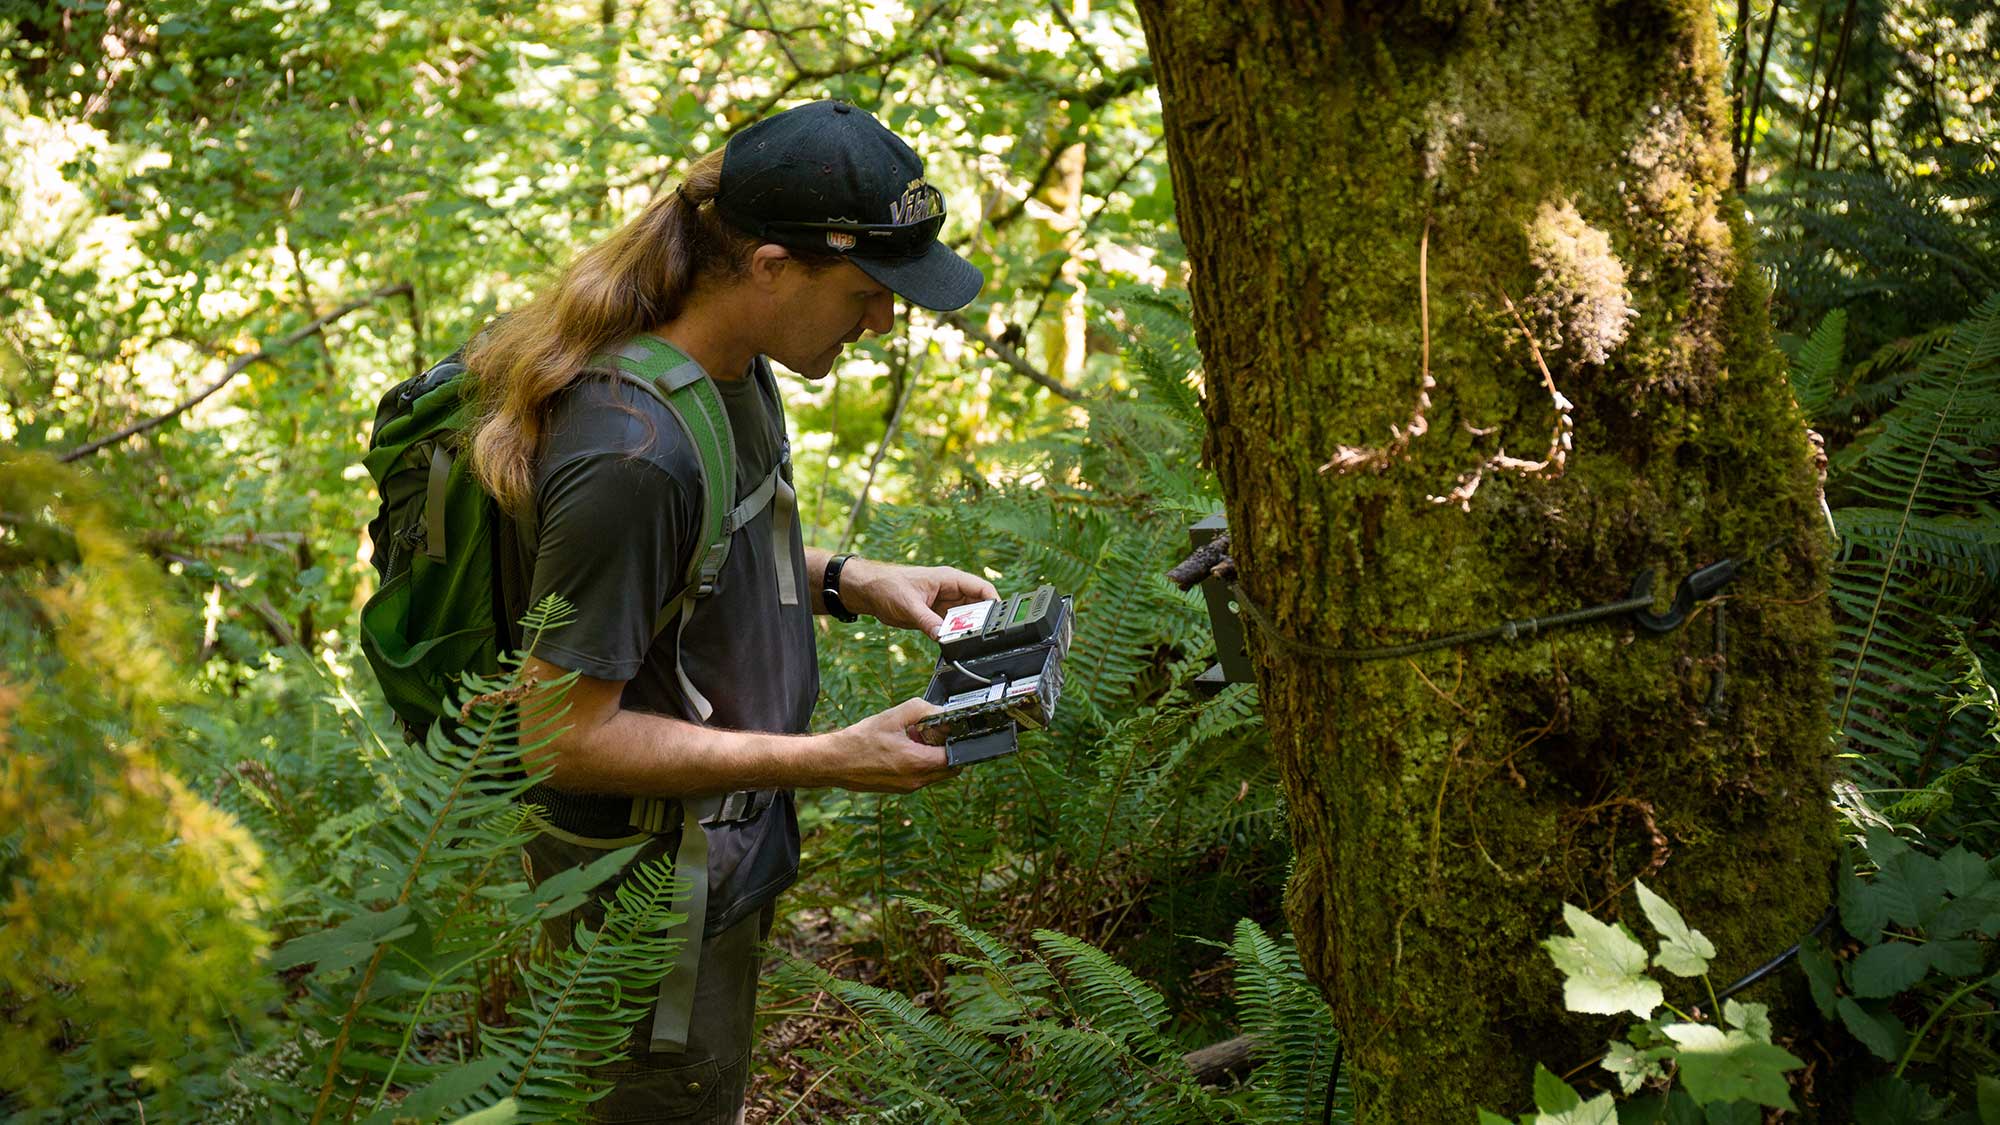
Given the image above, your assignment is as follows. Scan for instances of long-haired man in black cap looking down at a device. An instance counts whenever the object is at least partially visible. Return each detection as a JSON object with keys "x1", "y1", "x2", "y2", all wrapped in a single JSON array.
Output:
[{"x1": 466, "y1": 102, "x2": 996, "y2": 1123}]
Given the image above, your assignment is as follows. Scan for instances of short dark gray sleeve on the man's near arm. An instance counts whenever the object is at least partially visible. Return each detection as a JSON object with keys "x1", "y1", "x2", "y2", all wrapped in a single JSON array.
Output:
[{"x1": 528, "y1": 452, "x2": 698, "y2": 683}]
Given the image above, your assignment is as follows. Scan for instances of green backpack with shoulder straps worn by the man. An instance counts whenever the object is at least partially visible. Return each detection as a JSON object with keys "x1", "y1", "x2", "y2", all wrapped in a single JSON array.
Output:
[{"x1": 362, "y1": 334, "x2": 798, "y2": 739}]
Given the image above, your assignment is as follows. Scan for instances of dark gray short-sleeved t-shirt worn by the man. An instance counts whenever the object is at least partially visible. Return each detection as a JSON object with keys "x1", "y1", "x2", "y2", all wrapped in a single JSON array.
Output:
[{"x1": 518, "y1": 356, "x2": 820, "y2": 933}]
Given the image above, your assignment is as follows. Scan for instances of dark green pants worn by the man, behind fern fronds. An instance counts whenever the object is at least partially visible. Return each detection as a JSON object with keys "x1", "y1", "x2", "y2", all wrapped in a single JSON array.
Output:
[{"x1": 526, "y1": 835, "x2": 774, "y2": 1125}]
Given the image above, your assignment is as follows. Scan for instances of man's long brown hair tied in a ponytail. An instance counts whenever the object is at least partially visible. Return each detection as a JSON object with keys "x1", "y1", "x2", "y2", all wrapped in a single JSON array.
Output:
[{"x1": 466, "y1": 150, "x2": 828, "y2": 512}]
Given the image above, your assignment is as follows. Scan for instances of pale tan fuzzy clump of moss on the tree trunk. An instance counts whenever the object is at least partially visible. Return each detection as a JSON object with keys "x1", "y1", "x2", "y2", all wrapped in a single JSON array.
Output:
[{"x1": 1526, "y1": 200, "x2": 1636, "y2": 366}]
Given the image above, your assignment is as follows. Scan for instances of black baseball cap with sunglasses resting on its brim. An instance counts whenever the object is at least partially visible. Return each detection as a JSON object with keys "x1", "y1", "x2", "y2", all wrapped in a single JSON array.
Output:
[{"x1": 716, "y1": 102, "x2": 986, "y2": 312}]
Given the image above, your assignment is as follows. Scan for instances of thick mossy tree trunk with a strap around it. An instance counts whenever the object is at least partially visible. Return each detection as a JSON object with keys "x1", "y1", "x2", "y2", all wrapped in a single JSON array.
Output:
[{"x1": 1140, "y1": 0, "x2": 1834, "y2": 1123}]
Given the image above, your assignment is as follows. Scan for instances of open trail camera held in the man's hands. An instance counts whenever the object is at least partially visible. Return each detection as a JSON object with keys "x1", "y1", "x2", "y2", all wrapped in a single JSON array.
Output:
[{"x1": 916, "y1": 587, "x2": 1070, "y2": 765}]
